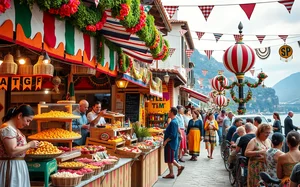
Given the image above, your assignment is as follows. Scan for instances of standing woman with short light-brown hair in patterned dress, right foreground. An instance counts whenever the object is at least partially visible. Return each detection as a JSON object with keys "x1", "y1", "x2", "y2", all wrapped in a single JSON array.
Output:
[{"x1": 245, "y1": 124, "x2": 272, "y2": 187}]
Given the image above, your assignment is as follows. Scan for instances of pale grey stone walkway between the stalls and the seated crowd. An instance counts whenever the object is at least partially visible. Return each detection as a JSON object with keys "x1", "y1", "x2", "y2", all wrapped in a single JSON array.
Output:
[{"x1": 154, "y1": 142, "x2": 231, "y2": 187}]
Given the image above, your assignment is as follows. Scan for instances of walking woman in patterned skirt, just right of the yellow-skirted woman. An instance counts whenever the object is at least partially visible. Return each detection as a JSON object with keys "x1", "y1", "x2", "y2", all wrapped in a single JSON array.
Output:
[{"x1": 204, "y1": 112, "x2": 219, "y2": 159}]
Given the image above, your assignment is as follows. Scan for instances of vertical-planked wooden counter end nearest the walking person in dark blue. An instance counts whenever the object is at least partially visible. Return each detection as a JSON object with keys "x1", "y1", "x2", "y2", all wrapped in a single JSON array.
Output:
[{"x1": 131, "y1": 148, "x2": 159, "y2": 187}]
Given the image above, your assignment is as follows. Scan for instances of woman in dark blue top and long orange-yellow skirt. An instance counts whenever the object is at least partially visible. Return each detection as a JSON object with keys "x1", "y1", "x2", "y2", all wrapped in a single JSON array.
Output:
[{"x1": 187, "y1": 111, "x2": 203, "y2": 161}]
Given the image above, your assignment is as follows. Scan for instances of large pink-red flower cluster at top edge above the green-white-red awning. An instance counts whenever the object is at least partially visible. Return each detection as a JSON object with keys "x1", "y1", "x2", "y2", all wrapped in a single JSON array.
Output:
[{"x1": 48, "y1": 0, "x2": 80, "y2": 18}]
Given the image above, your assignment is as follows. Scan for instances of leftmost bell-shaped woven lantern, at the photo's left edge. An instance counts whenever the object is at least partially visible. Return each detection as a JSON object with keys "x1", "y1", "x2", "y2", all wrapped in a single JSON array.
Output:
[{"x1": 0, "y1": 53, "x2": 18, "y2": 75}]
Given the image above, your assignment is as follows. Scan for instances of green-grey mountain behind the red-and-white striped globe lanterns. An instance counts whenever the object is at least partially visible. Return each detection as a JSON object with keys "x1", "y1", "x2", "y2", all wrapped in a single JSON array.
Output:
[{"x1": 190, "y1": 50, "x2": 279, "y2": 113}]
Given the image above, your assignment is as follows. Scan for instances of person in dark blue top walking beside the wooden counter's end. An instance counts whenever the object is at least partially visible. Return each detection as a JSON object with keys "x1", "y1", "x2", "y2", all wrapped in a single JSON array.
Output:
[{"x1": 163, "y1": 107, "x2": 184, "y2": 179}]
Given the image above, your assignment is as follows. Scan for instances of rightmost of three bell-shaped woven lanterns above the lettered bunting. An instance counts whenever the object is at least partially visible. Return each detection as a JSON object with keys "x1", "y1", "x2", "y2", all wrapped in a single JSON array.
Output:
[{"x1": 33, "y1": 55, "x2": 54, "y2": 77}]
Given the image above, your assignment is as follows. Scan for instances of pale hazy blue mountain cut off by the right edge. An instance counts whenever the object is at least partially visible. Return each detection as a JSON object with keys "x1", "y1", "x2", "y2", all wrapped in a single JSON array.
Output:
[{"x1": 273, "y1": 72, "x2": 300, "y2": 104}]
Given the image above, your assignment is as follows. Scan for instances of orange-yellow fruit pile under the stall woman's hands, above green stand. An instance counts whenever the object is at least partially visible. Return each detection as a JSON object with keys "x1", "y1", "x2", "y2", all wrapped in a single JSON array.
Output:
[{"x1": 26, "y1": 141, "x2": 62, "y2": 155}]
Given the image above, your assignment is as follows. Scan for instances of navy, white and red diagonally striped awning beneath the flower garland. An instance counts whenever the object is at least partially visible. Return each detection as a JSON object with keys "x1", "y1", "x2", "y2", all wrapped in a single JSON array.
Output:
[{"x1": 100, "y1": 10, "x2": 153, "y2": 63}]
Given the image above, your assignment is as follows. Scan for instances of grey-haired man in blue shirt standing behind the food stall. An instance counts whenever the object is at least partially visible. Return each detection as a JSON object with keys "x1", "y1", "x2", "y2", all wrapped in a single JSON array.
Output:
[{"x1": 72, "y1": 100, "x2": 90, "y2": 145}]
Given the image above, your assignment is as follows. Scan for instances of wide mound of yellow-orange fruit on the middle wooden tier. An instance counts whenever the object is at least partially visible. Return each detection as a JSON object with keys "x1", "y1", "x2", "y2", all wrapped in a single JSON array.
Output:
[{"x1": 29, "y1": 128, "x2": 81, "y2": 140}]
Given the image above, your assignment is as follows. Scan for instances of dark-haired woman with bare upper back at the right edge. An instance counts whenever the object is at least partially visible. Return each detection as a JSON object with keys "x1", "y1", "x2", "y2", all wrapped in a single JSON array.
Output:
[{"x1": 277, "y1": 131, "x2": 300, "y2": 187}]
